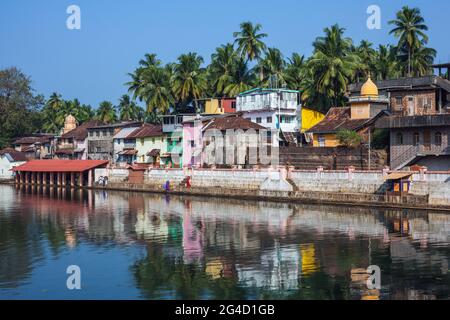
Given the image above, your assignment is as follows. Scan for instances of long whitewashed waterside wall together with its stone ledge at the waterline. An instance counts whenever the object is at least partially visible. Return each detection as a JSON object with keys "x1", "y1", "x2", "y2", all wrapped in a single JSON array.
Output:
[{"x1": 93, "y1": 167, "x2": 450, "y2": 211}]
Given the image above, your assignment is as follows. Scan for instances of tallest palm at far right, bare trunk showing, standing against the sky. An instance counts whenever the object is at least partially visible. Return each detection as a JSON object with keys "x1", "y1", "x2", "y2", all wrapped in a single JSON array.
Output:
[{"x1": 389, "y1": 6, "x2": 428, "y2": 77}]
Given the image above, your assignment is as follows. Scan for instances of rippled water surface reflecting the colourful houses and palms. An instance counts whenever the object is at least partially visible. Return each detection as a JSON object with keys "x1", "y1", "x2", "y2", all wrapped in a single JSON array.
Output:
[{"x1": 0, "y1": 186, "x2": 450, "y2": 299}]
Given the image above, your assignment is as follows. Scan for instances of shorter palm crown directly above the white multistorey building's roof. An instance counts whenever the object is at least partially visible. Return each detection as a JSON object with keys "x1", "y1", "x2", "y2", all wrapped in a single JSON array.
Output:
[{"x1": 258, "y1": 48, "x2": 286, "y2": 88}]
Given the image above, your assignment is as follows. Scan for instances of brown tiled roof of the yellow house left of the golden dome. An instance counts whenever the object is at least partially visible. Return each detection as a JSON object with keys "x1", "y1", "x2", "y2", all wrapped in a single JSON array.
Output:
[{"x1": 307, "y1": 107, "x2": 370, "y2": 133}]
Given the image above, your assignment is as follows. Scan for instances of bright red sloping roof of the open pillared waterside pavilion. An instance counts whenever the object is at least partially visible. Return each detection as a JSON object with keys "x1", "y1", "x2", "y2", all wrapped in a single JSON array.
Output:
[{"x1": 13, "y1": 160, "x2": 108, "y2": 172}]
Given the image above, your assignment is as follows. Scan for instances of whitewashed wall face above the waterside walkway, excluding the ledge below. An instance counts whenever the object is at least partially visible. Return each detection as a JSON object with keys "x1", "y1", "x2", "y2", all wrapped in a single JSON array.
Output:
[{"x1": 95, "y1": 167, "x2": 450, "y2": 206}]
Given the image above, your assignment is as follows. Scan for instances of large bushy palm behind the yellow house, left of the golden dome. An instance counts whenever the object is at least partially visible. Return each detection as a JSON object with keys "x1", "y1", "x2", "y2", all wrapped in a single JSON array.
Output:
[{"x1": 308, "y1": 24, "x2": 358, "y2": 111}]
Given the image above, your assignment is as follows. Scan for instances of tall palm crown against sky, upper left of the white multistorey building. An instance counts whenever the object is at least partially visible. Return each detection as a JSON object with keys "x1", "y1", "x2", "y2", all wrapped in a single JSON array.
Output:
[{"x1": 233, "y1": 22, "x2": 267, "y2": 62}]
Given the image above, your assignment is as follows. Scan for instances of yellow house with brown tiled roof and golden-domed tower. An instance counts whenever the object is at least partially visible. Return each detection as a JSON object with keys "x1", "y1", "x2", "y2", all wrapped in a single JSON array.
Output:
[{"x1": 306, "y1": 76, "x2": 389, "y2": 147}]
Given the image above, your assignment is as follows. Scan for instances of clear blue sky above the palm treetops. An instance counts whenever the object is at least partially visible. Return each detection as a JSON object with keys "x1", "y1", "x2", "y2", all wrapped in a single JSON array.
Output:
[{"x1": 0, "y1": 0, "x2": 450, "y2": 107}]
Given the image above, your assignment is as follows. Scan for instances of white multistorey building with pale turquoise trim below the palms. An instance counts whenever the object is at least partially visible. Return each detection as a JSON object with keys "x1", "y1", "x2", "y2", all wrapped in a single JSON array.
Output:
[{"x1": 236, "y1": 88, "x2": 301, "y2": 133}]
